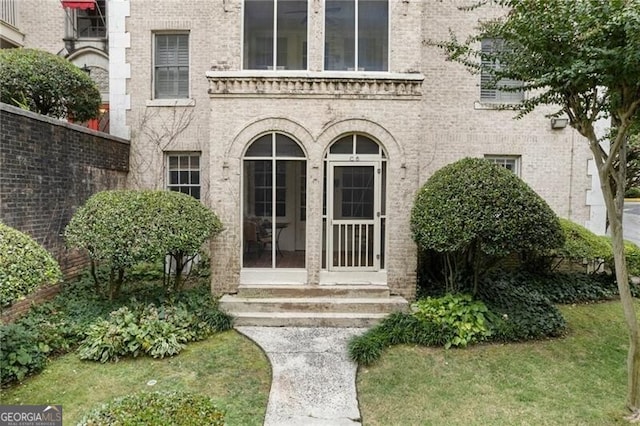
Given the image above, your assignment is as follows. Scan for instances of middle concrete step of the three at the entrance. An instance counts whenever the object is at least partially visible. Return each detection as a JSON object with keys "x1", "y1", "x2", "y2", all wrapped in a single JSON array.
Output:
[{"x1": 220, "y1": 295, "x2": 407, "y2": 315}]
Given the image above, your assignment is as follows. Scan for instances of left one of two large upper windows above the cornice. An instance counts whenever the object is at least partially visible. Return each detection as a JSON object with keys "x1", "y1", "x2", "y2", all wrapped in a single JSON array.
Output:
[{"x1": 244, "y1": 0, "x2": 307, "y2": 70}]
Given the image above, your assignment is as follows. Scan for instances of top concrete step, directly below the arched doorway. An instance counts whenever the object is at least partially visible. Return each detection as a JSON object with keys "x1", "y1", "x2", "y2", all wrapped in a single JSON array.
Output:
[{"x1": 238, "y1": 284, "x2": 390, "y2": 298}]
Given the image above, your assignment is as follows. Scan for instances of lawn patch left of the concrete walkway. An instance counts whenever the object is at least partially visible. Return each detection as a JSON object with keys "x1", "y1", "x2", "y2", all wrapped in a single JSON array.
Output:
[{"x1": 0, "y1": 331, "x2": 271, "y2": 426}]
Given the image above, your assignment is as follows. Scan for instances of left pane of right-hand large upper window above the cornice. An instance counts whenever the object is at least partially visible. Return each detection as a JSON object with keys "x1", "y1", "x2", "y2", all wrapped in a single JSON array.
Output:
[{"x1": 324, "y1": 0, "x2": 356, "y2": 71}]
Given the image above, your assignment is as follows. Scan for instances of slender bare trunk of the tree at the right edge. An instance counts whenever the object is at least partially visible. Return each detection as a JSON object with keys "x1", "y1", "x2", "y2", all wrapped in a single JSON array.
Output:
[{"x1": 598, "y1": 161, "x2": 640, "y2": 412}]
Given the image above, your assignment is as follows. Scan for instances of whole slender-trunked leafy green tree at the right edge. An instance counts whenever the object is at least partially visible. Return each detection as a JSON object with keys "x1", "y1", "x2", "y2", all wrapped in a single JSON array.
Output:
[{"x1": 433, "y1": 0, "x2": 640, "y2": 414}]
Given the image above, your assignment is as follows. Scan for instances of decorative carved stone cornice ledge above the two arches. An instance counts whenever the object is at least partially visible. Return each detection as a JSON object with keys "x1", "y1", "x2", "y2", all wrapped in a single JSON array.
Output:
[{"x1": 207, "y1": 70, "x2": 424, "y2": 100}]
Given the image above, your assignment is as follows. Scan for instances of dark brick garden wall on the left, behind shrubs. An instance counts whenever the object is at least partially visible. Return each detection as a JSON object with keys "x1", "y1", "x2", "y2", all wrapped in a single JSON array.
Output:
[{"x1": 0, "y1": 103, "x2": 129, "y2": 277}]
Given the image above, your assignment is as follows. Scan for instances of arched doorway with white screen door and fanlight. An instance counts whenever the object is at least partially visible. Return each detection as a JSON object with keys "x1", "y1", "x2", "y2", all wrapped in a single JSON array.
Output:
[{"x1": 322, "y1": 133, "x2": 387, "y2": 272}]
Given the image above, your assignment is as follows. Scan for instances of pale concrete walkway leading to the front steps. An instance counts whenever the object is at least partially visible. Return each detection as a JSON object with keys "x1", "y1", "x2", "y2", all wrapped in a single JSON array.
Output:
[{"x1": 237, "y1": 327, "x2": 366, "y2": 426}]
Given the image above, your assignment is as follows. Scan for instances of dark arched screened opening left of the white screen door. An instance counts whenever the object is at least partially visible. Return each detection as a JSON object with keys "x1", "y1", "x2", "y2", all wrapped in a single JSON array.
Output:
[{"x1": 242, "y1": 132, "x2": 307, "y2": 269}]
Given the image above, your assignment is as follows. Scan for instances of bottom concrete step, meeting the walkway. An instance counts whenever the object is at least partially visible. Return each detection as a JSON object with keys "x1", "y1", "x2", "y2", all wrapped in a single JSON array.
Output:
[{"x1": 234, "y1": 312, "x2": 387, "y2": 328}]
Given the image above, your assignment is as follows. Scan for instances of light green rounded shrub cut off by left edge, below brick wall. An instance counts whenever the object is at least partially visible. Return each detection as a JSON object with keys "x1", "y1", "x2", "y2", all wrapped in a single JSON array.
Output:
[{"x1": 0, "y1": 222, "x2": 62, "y2": 307}]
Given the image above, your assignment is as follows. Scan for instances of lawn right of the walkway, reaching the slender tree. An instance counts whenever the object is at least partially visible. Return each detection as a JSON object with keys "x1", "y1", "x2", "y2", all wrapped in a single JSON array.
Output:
[{"x1": 357, "y1": 302, "x2": 627, "y2": 426}]
